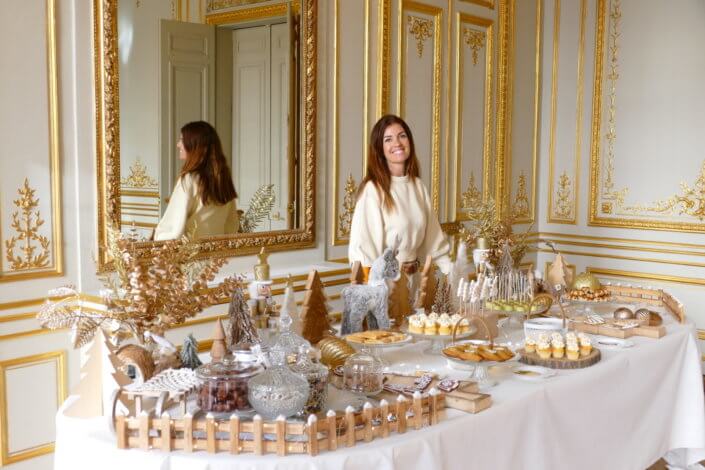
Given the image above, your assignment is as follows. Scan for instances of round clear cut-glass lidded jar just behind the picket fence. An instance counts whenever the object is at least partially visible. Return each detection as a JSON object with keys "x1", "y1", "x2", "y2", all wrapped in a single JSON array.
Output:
[{"x1": 248, "y1": 348, "x2": 308, "y2": 419}]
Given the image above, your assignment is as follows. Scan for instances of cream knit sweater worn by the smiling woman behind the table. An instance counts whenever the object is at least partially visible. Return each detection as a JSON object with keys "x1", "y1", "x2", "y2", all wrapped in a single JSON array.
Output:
[{"x1": 348, "y1": 176, "x2": 450, "y2": 273}]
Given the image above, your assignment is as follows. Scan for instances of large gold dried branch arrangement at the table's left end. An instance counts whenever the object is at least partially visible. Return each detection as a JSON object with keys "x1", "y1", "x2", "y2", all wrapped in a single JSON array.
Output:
[{"x1": 37, "y1": 228, "x2": 241, "y2": 348}]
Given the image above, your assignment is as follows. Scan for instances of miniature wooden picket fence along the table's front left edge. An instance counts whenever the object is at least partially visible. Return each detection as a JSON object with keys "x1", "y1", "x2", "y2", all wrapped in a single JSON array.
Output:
[{"x1": 115, "y1": 389, "x2": 445, "y2": 456}]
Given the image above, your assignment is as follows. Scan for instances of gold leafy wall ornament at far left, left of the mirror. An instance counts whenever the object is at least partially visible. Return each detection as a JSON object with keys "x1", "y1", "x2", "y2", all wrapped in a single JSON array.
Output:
[{"x1": 5, "y1": 178, "x2": 49, "y2": 271}]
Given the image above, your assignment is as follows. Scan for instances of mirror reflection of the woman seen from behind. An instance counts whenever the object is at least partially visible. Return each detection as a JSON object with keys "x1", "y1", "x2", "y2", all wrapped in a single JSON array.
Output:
[{"x1": 154, "y1": 121, "x2": 240, "y2": 240}]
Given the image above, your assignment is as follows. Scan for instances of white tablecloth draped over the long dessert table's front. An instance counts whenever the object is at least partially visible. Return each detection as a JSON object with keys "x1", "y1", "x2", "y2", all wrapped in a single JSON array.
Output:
[{"x1": 55, "y1": 323, "x2": 705, "y2": 470}]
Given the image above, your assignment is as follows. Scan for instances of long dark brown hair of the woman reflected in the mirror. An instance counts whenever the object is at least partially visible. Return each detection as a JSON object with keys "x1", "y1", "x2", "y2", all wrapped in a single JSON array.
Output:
[{"x1": 179, "y1": 121, "x2": 237, "y2": 205}]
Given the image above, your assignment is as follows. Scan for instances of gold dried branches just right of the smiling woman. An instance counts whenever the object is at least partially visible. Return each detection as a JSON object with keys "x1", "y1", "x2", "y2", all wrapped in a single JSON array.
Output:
[{"x1": 461, "y1": 198, "x2": 533, "y2": 266}]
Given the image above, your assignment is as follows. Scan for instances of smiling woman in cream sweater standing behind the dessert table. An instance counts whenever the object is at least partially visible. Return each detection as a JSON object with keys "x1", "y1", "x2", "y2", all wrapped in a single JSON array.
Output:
[{"x1": 348, "y1": 115, "x2": 450, "y2": 280}]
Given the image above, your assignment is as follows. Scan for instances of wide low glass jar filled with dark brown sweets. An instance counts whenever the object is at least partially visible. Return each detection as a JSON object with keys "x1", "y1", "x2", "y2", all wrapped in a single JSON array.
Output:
[{"x1": 196, "y1": 352, "x2": 264, "y2": 414}]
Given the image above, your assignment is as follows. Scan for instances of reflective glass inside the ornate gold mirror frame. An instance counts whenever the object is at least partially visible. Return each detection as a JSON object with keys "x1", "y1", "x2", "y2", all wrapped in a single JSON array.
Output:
[{"x1": 117, "y1": 0, "x2": 303, "y2": 240}]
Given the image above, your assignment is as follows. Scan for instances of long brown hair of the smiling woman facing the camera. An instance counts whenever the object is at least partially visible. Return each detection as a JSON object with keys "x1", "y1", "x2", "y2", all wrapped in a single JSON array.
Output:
[{"x1": 357, "y1": 114, "x2": 419, "y2": 210}]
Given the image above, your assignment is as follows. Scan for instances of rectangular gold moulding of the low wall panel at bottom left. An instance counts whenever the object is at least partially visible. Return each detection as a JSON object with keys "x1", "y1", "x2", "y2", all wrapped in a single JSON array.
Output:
[{"x1": 0, "y1": 349, "x2": 68, "y2": 467}]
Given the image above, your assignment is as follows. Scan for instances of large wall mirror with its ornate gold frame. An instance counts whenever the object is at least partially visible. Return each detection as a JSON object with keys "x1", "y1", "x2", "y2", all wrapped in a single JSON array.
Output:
[{"x1": 94, "y1": 0, "x2": 318, "y2": 271}]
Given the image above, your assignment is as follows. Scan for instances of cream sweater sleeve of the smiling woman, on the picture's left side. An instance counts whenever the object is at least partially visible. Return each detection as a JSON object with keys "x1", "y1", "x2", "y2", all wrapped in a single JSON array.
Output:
[{"x1": 348, "y1": 182, "x2": 385, "y2": 266}]
